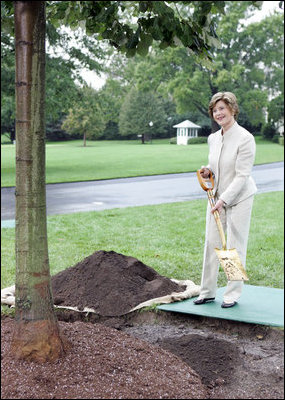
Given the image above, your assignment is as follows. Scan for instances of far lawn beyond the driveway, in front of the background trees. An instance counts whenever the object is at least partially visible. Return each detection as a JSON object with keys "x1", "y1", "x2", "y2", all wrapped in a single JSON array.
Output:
[{"x1": 1, "y1": 137, "x2": 284, "y2": 187}]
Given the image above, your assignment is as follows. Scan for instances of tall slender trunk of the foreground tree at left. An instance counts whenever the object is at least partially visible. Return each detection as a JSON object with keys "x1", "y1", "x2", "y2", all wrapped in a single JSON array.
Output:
[{"x1": 11, "y1": 1, "x2": 64, "y2": 362}]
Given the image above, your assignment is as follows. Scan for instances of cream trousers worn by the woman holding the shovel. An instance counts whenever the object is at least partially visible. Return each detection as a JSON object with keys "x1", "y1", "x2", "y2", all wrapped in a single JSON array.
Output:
[{"x1": 199, "y1": 196, "x2": 254, "y2": 303}]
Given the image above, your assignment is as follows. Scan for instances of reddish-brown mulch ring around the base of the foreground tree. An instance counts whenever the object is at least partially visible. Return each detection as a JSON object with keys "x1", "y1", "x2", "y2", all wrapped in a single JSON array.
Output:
[{"x1": 1, "y1": 317, "x2": 207, "y2": 399}]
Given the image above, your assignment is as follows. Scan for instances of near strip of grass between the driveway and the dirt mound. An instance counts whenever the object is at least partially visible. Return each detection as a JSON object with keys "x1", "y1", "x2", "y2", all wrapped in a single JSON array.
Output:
[{"x1": 1, "y1": 192, "x2": 284, "y2": 288}]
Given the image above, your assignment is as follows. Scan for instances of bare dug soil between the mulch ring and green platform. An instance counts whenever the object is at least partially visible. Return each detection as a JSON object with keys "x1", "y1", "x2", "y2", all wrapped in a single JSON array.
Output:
[{"x1": 121, "y1": 311, "x2": 284, "y2": 399}]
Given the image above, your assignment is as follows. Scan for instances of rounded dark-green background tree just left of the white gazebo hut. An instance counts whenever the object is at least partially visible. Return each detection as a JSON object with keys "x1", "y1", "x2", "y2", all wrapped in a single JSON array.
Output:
[{"x1": 119, "y1": 88, "x2": 167, "y2": 143}]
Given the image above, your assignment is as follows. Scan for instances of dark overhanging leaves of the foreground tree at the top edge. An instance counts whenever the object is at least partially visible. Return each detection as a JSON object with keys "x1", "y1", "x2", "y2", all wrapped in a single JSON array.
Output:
[{"x1": 48, "y1": 1, "x2": 229, "y2": 58}]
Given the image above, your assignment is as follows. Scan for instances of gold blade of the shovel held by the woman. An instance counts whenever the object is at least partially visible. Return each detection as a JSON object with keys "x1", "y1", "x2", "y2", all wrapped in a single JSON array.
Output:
[{"x1": 215, "y1": 249, "x2": 249, "y2": 281}]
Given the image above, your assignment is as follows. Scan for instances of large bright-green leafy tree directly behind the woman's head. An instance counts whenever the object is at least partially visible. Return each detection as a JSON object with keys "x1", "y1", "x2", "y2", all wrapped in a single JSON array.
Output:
[{"x1": 106, "y1": 2, "x2": 284, "y2": 133}]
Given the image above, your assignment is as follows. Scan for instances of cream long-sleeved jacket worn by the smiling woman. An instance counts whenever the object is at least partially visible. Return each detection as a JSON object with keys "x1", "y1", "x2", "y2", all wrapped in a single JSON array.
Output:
[{"x1": 207, "y1": 122, "x2": 257, "y2": 206}]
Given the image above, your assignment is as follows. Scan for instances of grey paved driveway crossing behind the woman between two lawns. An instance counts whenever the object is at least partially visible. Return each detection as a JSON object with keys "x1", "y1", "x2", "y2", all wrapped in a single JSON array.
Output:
[{"x1": 1, "y1": 162, "x2": 284, "y2": 220}]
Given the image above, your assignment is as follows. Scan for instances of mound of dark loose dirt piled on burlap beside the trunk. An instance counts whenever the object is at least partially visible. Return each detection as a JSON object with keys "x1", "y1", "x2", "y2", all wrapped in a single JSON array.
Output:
[{"x1": 51, "y1": 250, "x2": 185, "y2": 316}]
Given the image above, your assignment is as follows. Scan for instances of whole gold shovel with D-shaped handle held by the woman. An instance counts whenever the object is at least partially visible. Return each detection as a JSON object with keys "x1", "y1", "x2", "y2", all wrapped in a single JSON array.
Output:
[{"x1": 197, "y1": 169, "x2": 249, "y2": 281}]
